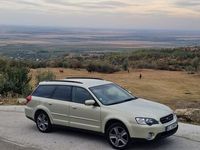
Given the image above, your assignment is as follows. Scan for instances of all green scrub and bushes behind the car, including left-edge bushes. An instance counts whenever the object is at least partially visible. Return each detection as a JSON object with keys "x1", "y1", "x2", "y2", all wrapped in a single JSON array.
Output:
[{"x1": 0, "y1": 47, "x2": 200, "y2": 97}]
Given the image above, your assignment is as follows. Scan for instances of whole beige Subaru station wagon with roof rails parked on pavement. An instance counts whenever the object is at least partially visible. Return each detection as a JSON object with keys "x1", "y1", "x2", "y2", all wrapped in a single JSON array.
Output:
[{"x1": 25, "y1": 77, "x2": 178, "y2": 149}]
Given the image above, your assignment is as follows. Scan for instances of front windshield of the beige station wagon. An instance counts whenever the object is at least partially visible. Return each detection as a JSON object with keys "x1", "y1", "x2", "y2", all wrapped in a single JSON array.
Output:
[{"x1": 90, "y1": 84, "x2": 136, "y2": 105}]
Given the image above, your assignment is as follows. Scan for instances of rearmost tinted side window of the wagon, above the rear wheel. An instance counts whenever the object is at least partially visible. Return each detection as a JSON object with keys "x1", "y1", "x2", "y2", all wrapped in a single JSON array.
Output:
[{"x1": 32, "y1": 85, "x2": 56, "y2": 98}]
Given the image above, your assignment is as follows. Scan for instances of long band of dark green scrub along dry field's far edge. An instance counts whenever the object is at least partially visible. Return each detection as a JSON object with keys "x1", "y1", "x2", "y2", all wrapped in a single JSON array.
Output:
[{"x1": 7, "y1": 47, "x2": 200, "y2": 73}]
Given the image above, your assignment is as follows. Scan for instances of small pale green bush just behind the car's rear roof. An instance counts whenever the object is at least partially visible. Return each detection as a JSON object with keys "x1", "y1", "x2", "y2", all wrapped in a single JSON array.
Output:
[{"x1": 36, "y1": 71, "x2": 56, "y2": 85}]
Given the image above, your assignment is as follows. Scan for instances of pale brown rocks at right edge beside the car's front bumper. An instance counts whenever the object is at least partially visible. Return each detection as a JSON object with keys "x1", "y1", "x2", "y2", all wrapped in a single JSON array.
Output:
[{"x1": 175, "y1": 108, "x2": 200, "y2": 123}]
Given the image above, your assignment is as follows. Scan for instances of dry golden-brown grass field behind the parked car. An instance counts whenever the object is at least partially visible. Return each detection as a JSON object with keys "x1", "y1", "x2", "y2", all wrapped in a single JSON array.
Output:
[{"x1": 31, "y1": 68, "x2": 200, "y2": 109}]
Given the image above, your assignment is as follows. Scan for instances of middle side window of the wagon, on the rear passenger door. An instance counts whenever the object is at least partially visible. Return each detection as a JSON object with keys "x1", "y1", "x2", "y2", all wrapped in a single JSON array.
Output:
[{"x1": 51, "y1": 85, "x2": 72, "y2": 101}]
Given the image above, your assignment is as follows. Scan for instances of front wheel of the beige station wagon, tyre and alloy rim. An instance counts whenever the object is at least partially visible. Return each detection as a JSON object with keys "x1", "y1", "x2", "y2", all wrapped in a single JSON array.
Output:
[{"x1": 106, "y1": 123, "x2": 130, "y2": 150}]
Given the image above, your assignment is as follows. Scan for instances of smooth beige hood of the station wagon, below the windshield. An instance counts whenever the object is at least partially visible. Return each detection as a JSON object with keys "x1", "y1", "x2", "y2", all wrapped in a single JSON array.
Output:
[{"x1": 110, "y1": 98, "x2": 173, "y2": 119}]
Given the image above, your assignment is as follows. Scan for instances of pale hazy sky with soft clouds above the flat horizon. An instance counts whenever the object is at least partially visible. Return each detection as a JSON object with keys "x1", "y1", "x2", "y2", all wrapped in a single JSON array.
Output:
[{"x1": 0, "y1": 0, "x2": 200, "y2": 30}]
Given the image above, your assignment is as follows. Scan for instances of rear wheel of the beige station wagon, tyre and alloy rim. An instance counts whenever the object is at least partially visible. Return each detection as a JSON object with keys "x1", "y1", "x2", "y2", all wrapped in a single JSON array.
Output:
[{"x1": 35, "y1": 111, "x2": 52, "y2": 133}]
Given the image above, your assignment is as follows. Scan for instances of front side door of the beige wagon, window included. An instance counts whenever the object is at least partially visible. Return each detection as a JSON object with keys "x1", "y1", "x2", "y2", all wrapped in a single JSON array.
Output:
[{"x1": 70, "y1": 87, "x2": 101, "y2": 131}]
